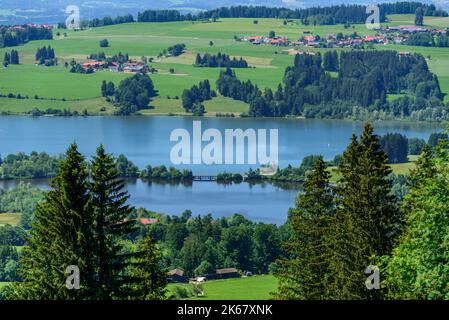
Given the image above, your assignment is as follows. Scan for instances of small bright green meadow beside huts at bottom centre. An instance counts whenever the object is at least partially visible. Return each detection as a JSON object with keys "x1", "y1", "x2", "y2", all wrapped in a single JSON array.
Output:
[{"x1": 168, "y1": 275, "x2": 277, "y2": 300}]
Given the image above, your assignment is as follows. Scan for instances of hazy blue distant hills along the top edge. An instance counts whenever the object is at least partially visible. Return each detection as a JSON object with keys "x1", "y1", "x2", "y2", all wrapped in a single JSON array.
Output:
[{"x1": 0, "y1": 0, "x2": 449, "y2": 24}]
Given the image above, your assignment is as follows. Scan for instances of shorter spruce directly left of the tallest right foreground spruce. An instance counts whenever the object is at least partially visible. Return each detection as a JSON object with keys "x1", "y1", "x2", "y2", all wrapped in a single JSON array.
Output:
[{"x1": 275, "y1": 157, "x2": 334, "y2": 300}]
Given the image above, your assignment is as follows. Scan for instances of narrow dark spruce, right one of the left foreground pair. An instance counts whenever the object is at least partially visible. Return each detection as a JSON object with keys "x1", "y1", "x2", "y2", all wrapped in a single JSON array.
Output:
[{"x1": 90, "y1": 146, "x2": 134, "y2": 300}]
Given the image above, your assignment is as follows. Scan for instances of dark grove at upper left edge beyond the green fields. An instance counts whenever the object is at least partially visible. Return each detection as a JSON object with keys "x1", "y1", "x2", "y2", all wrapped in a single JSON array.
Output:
[{"x1": 0, "y1": 25, "x2": 53, "y2": 48}]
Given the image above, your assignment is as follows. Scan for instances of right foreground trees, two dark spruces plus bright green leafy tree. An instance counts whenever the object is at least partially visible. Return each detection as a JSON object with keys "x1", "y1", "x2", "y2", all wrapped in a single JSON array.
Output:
[{"x1": 275, "y1": 125, "x2": 449, "y2": 300}]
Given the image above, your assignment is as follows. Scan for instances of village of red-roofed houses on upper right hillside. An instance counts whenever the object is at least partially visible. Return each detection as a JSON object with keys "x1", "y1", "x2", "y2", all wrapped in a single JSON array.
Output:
[{"x1": 242, "y1": 25, "x2": 448, "y2": 49}]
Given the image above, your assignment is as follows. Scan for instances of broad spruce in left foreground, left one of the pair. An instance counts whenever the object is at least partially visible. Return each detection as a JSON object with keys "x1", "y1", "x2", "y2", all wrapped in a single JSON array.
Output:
[{"x1": 13, "y1": 144, "x2": 92, "y2": 300}]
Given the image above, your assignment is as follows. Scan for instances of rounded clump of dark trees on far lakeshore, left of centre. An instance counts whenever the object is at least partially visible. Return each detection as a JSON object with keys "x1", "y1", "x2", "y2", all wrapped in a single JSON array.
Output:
[{"x1": 114, "y1": 74, "x2": 157, "y2": 115}]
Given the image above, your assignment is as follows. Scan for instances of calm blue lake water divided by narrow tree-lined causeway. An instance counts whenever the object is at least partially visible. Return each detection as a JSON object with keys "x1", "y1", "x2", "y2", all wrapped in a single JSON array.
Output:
[{"x1": 0, "y1": 116, "x2": 441, "y2": 223}]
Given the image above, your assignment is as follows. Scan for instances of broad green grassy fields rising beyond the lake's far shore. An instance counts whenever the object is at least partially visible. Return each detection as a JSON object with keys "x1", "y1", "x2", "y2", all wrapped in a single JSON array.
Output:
[{"x1": 0, "y1": 15, "x2": 449, "y2": 115}]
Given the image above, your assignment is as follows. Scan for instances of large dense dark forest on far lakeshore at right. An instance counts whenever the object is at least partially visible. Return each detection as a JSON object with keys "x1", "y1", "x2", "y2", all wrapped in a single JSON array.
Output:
[{"x1": 217, "y1": 51, "x2": 444, "y2": 118}]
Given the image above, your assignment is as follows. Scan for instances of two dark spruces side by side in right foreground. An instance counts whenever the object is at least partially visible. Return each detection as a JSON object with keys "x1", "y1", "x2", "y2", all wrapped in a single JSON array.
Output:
[{"x1": 276, "y1": 125, "x2": 402, "y2": 300}]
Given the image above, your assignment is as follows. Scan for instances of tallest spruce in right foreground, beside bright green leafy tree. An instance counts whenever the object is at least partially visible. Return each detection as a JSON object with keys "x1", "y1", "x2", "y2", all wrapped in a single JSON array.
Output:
[{"x1": 330, "y1": 124, "x2": 401, "y2": 299}]
